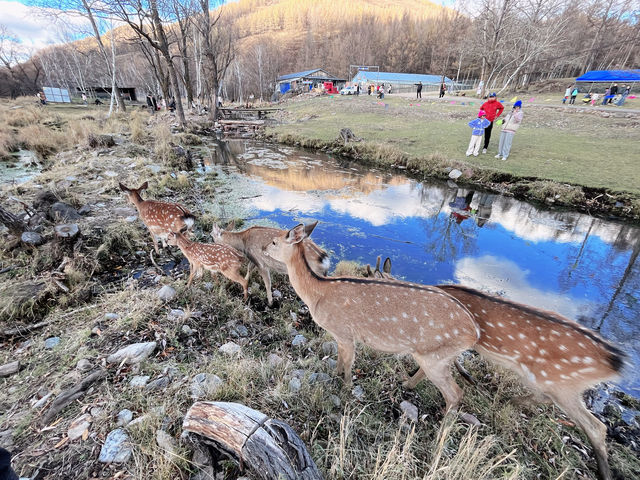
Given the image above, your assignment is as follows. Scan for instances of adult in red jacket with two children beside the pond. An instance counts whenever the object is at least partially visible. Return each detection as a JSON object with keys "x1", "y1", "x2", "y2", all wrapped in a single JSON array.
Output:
[{"x1": 467, "y1": 93, "x2": 523, "y2": 160}]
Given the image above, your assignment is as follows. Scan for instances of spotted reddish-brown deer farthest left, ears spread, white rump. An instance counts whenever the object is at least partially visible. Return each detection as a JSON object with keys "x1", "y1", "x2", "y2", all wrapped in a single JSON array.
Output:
[{"x1": 118, "y1": 182, "x2": 195, "y2": 253}]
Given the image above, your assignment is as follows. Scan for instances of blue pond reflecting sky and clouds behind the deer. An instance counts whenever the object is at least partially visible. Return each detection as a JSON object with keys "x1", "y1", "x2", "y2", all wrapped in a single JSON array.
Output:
[{"x1": 203, "y1": 141, "x2": 640, "y2": 397}]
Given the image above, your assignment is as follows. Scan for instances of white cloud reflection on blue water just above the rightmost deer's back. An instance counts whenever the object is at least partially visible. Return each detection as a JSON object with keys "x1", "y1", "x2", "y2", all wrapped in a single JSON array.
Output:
[{"x1": 455, "y1": 255, "x2": 596, "y2": 319}]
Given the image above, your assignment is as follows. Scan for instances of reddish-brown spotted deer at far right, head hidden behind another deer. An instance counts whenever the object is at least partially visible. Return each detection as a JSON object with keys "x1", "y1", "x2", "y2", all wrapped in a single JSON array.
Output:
[{"x1": 406, "y1": 285, "x2": 625, "y2": 480}]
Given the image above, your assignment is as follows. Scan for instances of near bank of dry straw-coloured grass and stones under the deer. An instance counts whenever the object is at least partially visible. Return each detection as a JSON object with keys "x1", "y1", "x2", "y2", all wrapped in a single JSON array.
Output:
[{"x1": 0, "y1": 98, "x2": 640, "y2": 480}]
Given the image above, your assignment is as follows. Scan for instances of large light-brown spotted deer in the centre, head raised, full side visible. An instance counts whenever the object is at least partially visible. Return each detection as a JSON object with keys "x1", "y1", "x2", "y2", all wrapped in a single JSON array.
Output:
[{"x1": 265, "y1": 222, "x2": 480, "y2": 411}]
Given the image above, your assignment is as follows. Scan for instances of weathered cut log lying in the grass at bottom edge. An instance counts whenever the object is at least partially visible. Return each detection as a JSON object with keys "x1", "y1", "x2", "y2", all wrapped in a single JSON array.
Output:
[{"x1": 182, "y1": 402, "x2": 322, "y2": 480}]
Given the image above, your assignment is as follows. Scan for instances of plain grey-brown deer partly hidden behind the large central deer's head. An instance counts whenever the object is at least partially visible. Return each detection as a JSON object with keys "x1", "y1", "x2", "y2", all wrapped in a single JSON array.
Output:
[{"x1": 211, "y1": 224, "x2": 329, "y2": 306}]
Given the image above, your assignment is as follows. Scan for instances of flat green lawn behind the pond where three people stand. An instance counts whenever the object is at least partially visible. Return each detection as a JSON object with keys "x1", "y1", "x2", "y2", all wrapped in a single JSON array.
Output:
[{"x1": 272, "y1": 95, "x2": 640, "y2": 194}]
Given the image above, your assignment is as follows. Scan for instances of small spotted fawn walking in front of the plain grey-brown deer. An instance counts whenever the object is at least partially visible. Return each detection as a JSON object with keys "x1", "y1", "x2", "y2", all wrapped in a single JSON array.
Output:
[{"x1": 168, "y1": 232, "x2": 248, "y2": 300}]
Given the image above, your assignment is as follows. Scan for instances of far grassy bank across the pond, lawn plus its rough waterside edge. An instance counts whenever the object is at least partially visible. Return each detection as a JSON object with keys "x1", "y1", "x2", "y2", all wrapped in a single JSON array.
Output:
[{"x1": 268, "y1": 95, "x2": 640, "y2": 219}]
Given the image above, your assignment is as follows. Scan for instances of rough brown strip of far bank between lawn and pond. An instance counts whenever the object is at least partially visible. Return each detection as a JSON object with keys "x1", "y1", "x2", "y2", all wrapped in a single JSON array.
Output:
[{"x1": 264, "y1": 133, "x2": 640, "y2": 223}]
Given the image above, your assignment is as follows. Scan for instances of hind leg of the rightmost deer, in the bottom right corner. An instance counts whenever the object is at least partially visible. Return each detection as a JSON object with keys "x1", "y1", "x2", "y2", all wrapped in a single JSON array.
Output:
[{"x1": 548, "y1": 391, "x2": 613, "y2": 480}]
